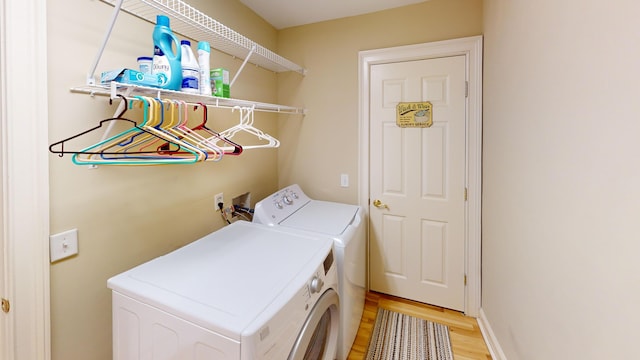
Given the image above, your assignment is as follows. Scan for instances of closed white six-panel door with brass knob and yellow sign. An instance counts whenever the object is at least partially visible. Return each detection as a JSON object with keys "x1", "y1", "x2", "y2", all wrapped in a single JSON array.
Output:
[{"x1": 369, "y1": 56, "x2": 466, "y2": 310}]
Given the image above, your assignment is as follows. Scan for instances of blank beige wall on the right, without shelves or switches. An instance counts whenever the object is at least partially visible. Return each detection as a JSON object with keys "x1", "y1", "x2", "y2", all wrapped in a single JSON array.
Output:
[{"x1": 482, "y1": 0, "x2": 640, "y2": 360}]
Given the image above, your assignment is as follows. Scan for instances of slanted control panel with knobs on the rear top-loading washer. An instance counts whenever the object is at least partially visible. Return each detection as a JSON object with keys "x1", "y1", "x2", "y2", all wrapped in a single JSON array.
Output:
[{"x1": 253, "y1": 184, "x2": 311, "y2": 225}]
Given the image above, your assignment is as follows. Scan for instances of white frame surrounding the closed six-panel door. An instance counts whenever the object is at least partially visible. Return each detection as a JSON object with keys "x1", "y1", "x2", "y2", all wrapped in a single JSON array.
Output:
[{"x1": 358, "y1": 35, "x2": 483, "y2": 317}]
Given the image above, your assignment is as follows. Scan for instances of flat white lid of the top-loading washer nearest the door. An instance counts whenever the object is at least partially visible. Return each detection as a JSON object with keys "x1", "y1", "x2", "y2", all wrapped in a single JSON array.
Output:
[{"x1": 280, "y1": 200, "x2": 359, "y2": 236}]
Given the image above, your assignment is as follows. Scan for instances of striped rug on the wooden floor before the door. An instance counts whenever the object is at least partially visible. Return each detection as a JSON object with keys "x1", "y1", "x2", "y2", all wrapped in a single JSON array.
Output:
[{"x1": 366, "y1": 309, "x2": 453, "y2": 360}]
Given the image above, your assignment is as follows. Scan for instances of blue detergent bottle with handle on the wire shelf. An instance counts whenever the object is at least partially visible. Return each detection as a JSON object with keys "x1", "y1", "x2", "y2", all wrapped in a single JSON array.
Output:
[{"x1": 152, "y1": 15, "x2": 182, "y2": 91}]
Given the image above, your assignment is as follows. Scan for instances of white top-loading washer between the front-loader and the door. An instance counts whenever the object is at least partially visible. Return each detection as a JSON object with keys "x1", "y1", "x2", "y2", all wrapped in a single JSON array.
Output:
[{"x1": 253, "y1": 184, "x2": 366, "y2": 360}]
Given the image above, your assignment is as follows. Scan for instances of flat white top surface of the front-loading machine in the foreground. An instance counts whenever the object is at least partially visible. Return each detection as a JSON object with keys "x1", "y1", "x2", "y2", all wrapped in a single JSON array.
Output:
[{"x1": 108, "y1": 221, "x2": 332, "y2": 341}]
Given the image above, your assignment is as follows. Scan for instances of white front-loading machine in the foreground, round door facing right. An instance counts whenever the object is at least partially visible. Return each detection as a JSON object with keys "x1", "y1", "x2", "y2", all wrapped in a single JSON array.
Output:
[{"x1": 107, "y1": 221, "x2": 340, "y2": 360}]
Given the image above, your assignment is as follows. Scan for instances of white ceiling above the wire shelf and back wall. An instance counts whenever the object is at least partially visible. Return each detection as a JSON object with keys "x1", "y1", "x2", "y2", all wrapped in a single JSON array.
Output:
[{"x1": 240, "y1": 0, "x2": 426, "y2": 29}]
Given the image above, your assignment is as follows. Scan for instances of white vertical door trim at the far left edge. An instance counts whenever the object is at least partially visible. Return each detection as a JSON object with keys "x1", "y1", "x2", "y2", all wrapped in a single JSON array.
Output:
[{"x1": 0, "y1": 0, "x2": 51, "y2": 360}]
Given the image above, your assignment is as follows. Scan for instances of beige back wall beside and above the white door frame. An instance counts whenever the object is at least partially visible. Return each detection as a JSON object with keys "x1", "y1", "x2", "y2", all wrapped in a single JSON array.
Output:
[{"x1": 278, "y1": 0, "x2": 482, "y2": 203}]
